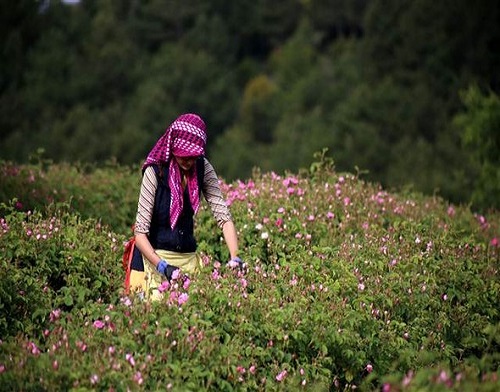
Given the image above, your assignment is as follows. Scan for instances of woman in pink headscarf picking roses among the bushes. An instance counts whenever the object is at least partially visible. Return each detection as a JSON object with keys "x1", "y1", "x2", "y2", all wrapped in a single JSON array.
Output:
[{"x1": 130, "y1": 113, "x2": 241, "y2": 299}]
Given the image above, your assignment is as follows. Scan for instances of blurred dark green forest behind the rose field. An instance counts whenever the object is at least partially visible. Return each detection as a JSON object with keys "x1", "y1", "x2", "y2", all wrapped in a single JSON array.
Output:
[{"x1": 0, "y1": 0, "x2": 500, "y2": 210}]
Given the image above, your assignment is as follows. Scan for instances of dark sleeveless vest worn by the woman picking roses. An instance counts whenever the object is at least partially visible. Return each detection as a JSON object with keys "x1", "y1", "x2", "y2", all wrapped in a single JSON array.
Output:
[{"x1": 131, "y1": 158, "x2": 205, "y2": 271}]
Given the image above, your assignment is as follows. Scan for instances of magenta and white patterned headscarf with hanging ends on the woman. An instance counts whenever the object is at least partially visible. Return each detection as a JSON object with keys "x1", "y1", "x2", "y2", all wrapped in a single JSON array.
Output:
[{"x1": 142, "y1": 113, "x2": 207, "y2": 229}]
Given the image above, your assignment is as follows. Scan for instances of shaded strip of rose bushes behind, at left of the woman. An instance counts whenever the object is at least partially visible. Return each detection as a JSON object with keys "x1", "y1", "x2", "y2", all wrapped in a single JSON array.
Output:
[{"x1": 0, "y1": 151, "x2": 141, "y2": 234}]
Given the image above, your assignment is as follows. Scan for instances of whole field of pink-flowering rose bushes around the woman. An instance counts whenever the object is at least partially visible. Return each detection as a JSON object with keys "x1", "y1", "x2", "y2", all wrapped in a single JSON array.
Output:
[{"x1": 0, "y1": 154, "x2": 500, "y2": 391}]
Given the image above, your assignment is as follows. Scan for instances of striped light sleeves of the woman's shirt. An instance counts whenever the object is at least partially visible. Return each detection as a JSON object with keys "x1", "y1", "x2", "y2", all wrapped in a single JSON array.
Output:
[{"x1": 134, "y1": 158, "x2": 232, "y2": 234}]
